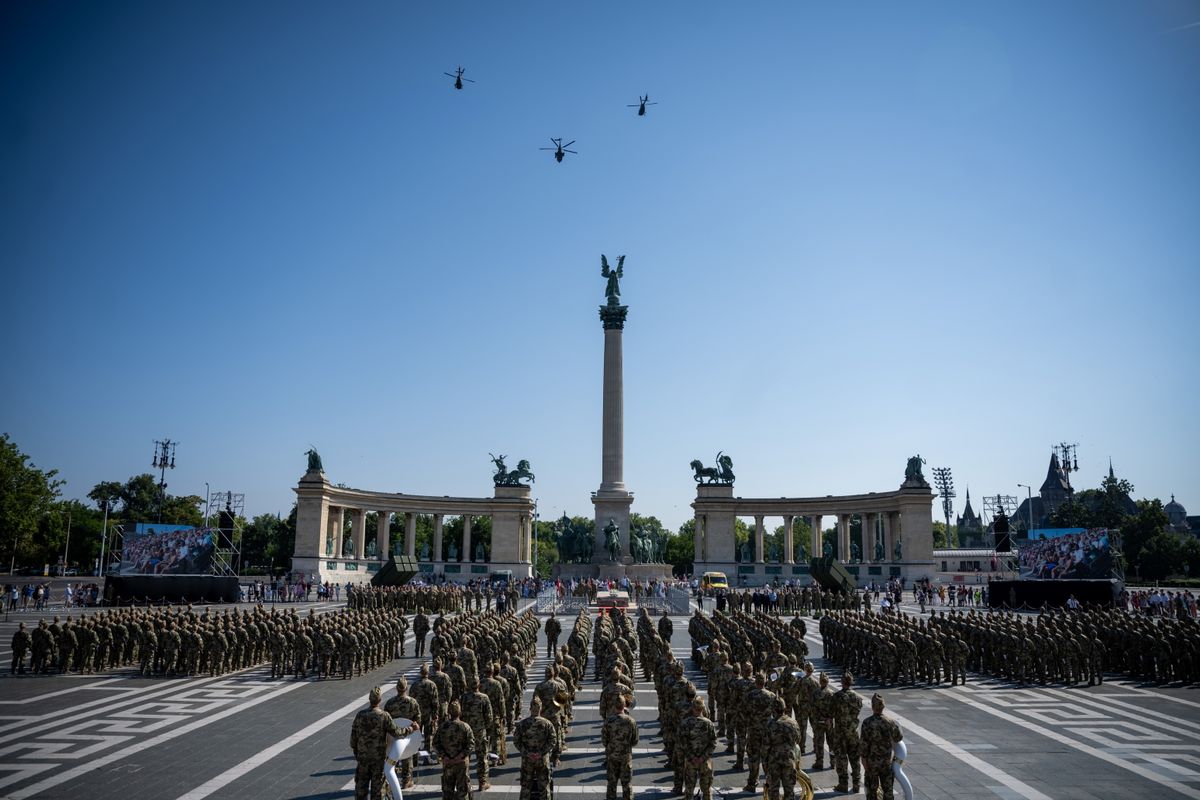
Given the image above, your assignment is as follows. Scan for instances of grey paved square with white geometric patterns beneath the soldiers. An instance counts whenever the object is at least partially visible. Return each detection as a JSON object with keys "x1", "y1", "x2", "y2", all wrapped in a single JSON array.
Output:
[{"x1": 0, "y1": 604, "x2": 1200, "y2": 800}]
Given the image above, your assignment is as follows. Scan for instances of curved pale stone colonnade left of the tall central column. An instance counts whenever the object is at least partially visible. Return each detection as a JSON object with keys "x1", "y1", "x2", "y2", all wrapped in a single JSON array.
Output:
[{"x1": 292, "y1": 471, "x2": 534, "y2": 583}]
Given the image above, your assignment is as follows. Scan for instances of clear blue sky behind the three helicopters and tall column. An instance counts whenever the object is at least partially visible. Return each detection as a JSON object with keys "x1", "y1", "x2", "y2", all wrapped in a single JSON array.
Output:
[{"x1": 0, "y1": 0, "x2": 1200, "y2": 527}]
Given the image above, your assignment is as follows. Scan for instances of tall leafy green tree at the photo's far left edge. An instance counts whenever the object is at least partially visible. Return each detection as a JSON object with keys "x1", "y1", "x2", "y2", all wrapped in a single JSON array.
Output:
[{"x1": 0, "y1": 433, "x2": 64, "y2": 573}]
